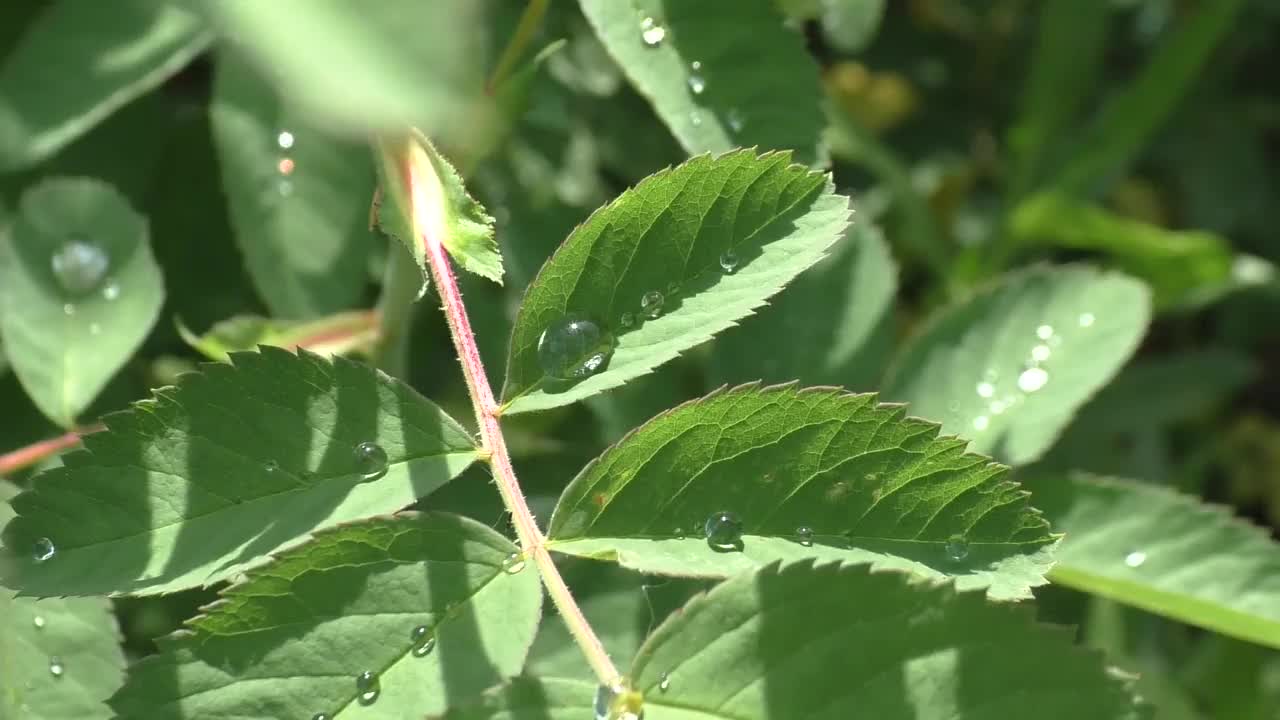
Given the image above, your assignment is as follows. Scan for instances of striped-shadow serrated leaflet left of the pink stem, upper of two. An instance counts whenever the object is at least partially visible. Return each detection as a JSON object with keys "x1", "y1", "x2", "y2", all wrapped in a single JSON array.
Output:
[{"x1": 4, "y1": 347, "x2": 476, "y2": 596}]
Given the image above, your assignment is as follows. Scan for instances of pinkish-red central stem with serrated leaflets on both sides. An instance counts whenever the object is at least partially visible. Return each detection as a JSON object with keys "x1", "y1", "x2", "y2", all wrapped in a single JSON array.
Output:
[{"x1": 408, "y1": 165, "x2": 620, "y2": 684}]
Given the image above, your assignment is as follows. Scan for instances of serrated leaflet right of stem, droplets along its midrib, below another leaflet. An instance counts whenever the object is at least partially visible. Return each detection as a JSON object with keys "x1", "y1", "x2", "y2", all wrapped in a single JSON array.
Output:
[{"x1": 548, "y1": 386, "x2": 1055, "y2": 598}]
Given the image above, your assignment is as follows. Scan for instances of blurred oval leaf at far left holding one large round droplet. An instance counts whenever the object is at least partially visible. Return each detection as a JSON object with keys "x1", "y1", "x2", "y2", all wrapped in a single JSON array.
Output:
[{"x1": 0, "y1": 178, "x2": 164, "y2": 427}]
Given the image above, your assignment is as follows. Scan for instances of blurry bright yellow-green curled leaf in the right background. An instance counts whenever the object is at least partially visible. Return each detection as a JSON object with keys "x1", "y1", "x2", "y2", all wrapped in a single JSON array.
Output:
[{"x1": 1009, "y1": 193, "x2": 1234, "y2": 307}]
